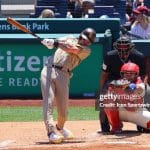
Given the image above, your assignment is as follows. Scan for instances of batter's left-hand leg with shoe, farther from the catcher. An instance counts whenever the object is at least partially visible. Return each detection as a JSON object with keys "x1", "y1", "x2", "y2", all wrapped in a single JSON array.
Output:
[{"x1": 41, "y1": 67, "x2": 63, "y2": 144}]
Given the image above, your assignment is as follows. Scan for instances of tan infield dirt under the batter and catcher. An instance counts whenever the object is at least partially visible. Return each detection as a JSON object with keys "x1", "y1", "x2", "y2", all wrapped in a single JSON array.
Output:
[{"x1": 0, "y1": 100, "x2": 150, "y2": 150}]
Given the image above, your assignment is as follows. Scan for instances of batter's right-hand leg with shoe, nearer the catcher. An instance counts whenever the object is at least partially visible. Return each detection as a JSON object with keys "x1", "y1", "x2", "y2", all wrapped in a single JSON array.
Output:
[{"x1": 55, "y1": 70, "x2": 73, "y2": 139}]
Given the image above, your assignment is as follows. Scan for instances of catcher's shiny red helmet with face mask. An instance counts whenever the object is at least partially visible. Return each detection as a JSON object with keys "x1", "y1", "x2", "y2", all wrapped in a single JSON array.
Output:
[{"x1": 120, "y1": 62, "x2": 140, "y2": 81}]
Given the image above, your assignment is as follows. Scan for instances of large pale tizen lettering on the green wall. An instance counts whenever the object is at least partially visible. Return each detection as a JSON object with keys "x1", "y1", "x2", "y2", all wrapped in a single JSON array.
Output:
[{"x1": 0, "y1": 51, "x2": 48, "y2": 72}]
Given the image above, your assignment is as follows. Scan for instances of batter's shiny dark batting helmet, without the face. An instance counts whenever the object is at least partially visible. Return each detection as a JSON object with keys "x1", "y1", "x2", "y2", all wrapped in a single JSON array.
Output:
[{"x1": 80, "y1": 28, "x2": 96, "y2": 43}]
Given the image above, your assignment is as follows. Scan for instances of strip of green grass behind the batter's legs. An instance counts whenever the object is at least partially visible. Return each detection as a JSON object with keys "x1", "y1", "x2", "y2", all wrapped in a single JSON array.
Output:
[{"x1": 0, "y1": 107, "x2": 98, "y2": 122}]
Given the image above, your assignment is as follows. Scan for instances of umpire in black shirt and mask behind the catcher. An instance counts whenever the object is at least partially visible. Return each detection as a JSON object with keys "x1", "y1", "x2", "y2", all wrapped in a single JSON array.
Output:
[{"x1": 99, "y1": 36, "x2": 145, "y2": 134}]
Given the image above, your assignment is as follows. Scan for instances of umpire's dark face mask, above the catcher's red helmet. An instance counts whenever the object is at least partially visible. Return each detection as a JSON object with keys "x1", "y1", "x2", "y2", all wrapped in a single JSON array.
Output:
[{"x1": 113, "y1": 37, "x2": 134, "y2": 60}]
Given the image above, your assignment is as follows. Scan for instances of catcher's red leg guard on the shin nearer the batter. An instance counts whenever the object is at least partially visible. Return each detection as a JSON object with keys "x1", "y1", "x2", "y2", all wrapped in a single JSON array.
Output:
[{"x1": 105, "y1": 109, "x2": 123, "y2": 132}]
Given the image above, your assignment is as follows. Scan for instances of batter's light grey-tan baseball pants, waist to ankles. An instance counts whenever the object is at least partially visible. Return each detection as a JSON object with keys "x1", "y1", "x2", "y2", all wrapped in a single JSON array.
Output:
[{"x1": 41, "y1": 64, "x2": 70, "y2": 133}]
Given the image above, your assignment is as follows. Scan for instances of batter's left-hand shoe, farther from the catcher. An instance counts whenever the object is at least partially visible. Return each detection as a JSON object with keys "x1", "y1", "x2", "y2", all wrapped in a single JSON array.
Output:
[{"x1": 48, "y1": 132, "x2": 64, "y2": 144}]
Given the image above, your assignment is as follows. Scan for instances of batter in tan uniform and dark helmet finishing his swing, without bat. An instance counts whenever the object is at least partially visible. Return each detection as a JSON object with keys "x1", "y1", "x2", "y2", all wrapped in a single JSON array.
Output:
[{"x1": 41, "y1": 28, "x2": 96, "y2": 144}]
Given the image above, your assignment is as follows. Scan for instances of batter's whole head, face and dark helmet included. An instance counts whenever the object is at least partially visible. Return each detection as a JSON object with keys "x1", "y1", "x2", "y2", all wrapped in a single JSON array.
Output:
[{"x1": 79, "y1": 28, "x2": 96, "y2": 46}]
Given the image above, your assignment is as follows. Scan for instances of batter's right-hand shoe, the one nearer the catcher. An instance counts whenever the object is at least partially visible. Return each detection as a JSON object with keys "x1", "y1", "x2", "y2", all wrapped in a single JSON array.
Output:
[{"x1": 59, "y1": 128, "x2": 74, "y2": 140}]
